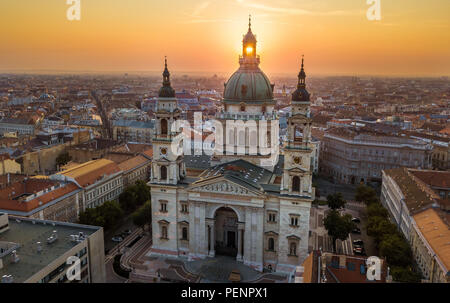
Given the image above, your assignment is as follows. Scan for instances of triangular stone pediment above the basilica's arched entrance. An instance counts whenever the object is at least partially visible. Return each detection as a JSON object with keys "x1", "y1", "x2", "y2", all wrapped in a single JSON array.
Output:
[{"x1": 188, "y1": 176, "x2": 264, "y2": 197}]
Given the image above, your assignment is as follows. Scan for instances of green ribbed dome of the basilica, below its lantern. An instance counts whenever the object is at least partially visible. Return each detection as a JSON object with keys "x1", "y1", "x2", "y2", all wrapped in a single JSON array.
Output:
[{"x1": 223, "y1": 68, "x2": 274, "y2": 103}]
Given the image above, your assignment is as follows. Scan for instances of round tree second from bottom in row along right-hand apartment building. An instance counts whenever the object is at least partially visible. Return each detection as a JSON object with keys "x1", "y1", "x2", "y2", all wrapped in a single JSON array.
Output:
[{"x1": 380, "y1": 233, "x2": 412, "y2": 267}]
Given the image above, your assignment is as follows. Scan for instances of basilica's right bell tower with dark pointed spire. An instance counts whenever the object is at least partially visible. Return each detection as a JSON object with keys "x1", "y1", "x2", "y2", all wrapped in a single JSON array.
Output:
[{"x1": 281, "y1": 58, "x2": 313, "y2": 197}]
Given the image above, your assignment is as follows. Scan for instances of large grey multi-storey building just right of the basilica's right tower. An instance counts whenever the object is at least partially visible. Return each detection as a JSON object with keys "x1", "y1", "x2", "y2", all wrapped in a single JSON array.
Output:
[{"x1": 320, "y1": 127, "x2": 432, "y2": 184}]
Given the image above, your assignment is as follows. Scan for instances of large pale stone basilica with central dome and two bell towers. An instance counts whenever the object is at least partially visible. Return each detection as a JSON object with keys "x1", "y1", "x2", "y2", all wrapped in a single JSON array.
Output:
[{"x1": 148, "y1": 22, "x2": 315, "y2": 272}]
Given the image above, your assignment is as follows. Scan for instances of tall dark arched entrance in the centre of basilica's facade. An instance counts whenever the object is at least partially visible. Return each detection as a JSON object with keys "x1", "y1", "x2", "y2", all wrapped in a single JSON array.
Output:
[{"x1": 214, "y1": 207, "x2": 238, "y2": 257}]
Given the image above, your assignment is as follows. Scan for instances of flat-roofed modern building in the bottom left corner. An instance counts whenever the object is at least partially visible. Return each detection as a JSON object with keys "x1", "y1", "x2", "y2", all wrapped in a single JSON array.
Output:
[{"x1": 0, "y1": 213, "x2": 105, "y2": 283}]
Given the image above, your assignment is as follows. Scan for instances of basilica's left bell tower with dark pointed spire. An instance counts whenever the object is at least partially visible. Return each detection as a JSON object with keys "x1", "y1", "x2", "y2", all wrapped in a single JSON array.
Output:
[{"x1": 150, "y1": 58, "x2": 186, "y2": 185}]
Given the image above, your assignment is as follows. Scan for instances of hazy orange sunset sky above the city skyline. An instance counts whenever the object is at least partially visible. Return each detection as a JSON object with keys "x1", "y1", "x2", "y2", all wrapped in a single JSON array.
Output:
[{"x1": 0, "y1": 0, "x2": 450, "y2": 76}]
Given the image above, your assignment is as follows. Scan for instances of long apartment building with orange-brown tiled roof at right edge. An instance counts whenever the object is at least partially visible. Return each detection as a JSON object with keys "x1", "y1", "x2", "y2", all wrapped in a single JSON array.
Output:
[{"x1": 381, "y1": 168, "x2": 450, "y2": 283}]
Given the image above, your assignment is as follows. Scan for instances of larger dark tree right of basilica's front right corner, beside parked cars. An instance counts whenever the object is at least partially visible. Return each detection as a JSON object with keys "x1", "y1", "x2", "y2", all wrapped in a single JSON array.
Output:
[{"x1": 324, "y1": 210, "x2": 356, "y2": 251}]
